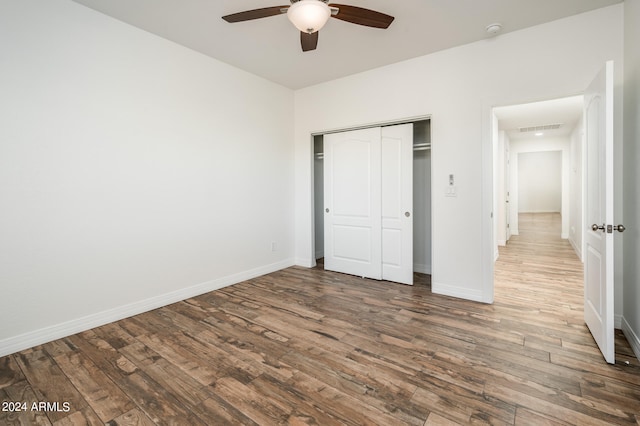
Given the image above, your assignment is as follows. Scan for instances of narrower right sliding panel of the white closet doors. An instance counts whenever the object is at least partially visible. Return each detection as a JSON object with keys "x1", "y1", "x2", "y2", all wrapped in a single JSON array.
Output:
[{"x1": 381, "y1": 124, "x2": 413, "y2": 284}]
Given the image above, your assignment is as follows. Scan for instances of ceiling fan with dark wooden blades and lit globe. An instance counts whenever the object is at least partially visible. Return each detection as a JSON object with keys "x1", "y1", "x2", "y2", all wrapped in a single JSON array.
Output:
[{"x1": 222, "y1": 0, "x2": 394, "y2": 52}]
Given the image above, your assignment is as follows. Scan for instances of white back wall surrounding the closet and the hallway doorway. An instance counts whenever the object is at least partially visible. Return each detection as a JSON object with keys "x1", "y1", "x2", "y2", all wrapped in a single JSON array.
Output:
[{"x1": 295, "y1": 4, "x2": 623, "y2": 302}]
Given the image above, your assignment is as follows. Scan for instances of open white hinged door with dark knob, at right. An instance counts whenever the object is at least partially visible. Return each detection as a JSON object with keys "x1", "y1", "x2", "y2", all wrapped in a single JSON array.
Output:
[{"x1": 584, "y1": 61, "x2": 615, "y2": 364}]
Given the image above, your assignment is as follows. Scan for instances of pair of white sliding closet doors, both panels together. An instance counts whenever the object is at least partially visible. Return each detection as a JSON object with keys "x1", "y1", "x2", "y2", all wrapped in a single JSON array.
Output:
[{"x1": 324, "y1": 124, "x2": 413, "y2": 284}]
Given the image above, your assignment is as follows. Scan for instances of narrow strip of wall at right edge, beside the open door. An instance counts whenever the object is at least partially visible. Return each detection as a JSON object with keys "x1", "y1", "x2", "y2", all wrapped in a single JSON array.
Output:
[{"x1": 616, "y1": 0, "x2": 640, "y2": 358}]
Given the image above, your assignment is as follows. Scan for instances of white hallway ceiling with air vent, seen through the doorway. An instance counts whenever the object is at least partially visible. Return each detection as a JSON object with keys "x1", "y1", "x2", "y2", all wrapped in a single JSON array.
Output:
[{"x1": 493, "y1": 96, "x2": 583, "y2": 140}]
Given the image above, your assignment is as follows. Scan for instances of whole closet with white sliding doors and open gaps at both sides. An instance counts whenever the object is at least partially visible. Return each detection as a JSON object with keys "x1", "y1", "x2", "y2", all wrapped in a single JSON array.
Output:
[{"x1": 314, "y1": 120, "x2": 431, "y2": 284}]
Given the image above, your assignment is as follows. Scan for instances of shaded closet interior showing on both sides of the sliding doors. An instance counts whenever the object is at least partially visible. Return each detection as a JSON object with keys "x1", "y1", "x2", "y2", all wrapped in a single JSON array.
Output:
[{"x1": 313, "y1": 118, "x2": 432, "y2": 282}]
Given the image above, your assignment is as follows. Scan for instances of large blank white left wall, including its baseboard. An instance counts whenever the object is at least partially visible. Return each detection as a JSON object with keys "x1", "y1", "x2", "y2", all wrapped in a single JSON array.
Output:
[{"x1": 0, "y1": 0, "x2": 296, "y2": 356}]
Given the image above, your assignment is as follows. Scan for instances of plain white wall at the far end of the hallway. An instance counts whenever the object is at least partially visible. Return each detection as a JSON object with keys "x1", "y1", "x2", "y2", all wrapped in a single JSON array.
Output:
[{"x1": 517, "y1": 151, "x2": 562, "y2": 213}]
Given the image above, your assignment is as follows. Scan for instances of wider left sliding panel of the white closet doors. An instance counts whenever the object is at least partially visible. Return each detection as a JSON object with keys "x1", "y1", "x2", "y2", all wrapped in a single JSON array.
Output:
[{"x1": 324, "y1": 128, "x2": 382, "y2": 279}]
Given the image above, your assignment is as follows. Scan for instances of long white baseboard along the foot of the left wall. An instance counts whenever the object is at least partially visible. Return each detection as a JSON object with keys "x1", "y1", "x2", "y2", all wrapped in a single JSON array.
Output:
[{"x1": 0, "y1": 259, "x2": 294, "y2": 357}]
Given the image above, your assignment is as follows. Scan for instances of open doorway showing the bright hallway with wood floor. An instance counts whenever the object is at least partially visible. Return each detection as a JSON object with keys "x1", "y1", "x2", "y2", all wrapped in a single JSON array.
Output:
[{"x1": 493, "y1": 96, "x2": 584, "y2": 316}]
